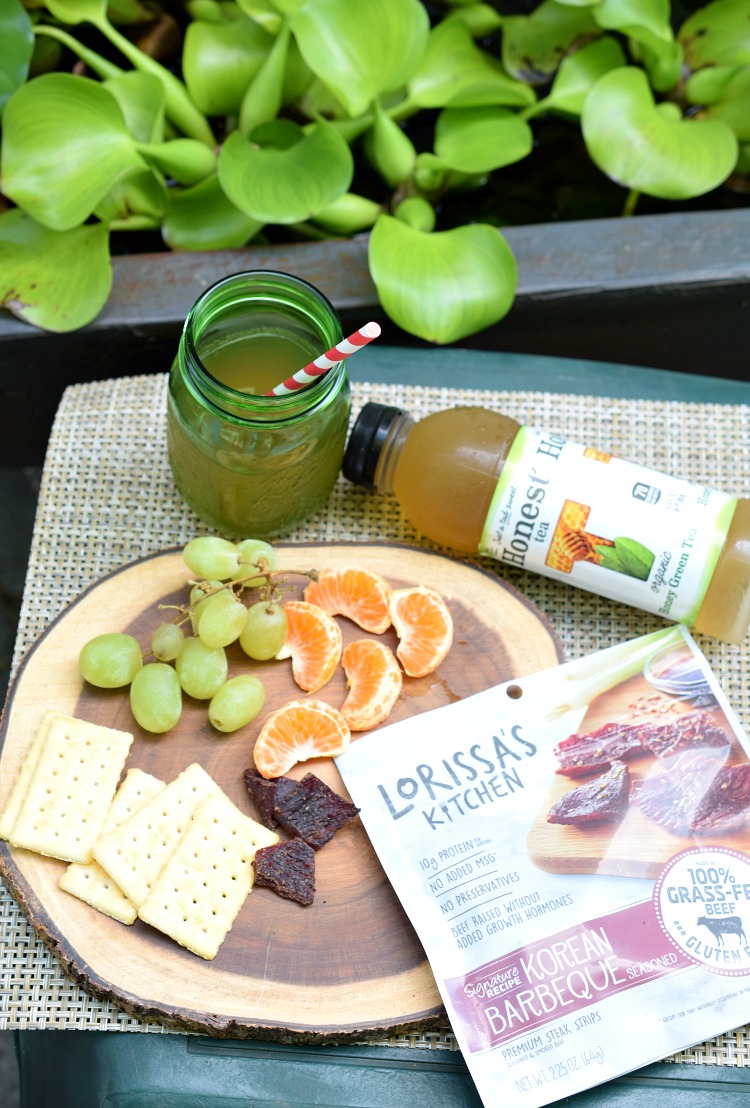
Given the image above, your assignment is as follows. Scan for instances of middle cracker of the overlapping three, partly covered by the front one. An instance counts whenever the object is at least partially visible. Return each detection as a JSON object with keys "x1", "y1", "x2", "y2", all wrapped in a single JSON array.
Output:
[{"x1": 93, "y1": 762, "x2": 220, "y2": 907}]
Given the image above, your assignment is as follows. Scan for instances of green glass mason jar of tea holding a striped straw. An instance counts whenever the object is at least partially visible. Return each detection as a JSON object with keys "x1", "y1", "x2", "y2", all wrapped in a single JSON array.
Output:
[{"x1": 167, "y1": 270, "x2": 351, "y2": 538}]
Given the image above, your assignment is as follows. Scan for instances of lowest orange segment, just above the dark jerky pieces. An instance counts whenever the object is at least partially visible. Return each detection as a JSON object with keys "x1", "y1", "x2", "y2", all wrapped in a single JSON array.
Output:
[{"x1": 253, "y1": 699, "x2": 351, "y2": 778}]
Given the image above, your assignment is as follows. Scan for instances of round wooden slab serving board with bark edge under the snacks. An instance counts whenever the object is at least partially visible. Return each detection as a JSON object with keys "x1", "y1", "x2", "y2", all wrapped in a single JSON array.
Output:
[{"x1": 0, "y1": 543, "x2": 562, "y2": 1042}]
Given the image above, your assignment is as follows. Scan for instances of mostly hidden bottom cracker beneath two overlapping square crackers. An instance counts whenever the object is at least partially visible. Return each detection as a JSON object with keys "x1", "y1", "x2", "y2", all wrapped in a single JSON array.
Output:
[{"x1": 59, "y1": 769, "x2": 165, "y2": 924}]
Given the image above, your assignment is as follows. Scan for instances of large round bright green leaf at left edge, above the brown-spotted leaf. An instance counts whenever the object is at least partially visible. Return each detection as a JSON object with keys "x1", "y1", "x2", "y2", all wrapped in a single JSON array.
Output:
[{"x1": 2, "y1": 73, "x2": 144, "y2": 230}]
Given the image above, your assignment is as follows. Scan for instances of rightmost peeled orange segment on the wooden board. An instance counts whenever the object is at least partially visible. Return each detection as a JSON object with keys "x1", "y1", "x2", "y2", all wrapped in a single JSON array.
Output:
[{"x1": 390, "y1": 585, "x2": 453, "y2": 677}]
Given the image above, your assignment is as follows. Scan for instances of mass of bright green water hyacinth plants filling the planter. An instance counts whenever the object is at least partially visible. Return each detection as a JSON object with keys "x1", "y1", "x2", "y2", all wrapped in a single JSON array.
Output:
[{"x1": 0, "y1": 0, "x2": 750, "y2": 343}]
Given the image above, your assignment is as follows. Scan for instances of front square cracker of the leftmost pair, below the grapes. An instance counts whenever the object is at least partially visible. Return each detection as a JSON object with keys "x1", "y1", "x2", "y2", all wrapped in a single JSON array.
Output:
[{"x1": 8, "y1": 712, "x2": 133, "y2": 862}]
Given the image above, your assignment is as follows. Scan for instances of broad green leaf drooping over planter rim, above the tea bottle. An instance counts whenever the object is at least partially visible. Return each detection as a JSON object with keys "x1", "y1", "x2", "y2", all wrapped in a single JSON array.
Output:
[{"x1": 369, "y1": 215, "x2": 516, "y2": 343}]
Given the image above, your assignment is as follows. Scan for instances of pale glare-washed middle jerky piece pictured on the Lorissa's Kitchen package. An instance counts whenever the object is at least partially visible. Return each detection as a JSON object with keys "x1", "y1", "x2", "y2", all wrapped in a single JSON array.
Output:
[{"x1": 633, "y1": 750, "x2": 722, "y2": 835}]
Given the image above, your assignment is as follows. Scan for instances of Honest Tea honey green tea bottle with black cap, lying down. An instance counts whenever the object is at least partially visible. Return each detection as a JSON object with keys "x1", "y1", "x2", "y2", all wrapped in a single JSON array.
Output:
[{"x1": 343, "y1": 403, "x2": 750, "y2": 643}]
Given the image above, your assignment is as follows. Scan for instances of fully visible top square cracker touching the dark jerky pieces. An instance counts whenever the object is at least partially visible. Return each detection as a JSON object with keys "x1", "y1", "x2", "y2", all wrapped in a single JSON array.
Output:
[{"x1": 138, "y1": 792, "x2": 278, "y2": 960}]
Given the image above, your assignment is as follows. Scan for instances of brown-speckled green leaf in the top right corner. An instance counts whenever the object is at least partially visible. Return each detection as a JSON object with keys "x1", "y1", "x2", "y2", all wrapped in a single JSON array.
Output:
[{"x1": 677, "y1": 0, "x2": 750, "y2": 71}]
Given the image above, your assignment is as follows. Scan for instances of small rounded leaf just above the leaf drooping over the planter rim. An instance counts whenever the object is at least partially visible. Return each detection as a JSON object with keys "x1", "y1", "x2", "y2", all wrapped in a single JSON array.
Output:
[{"x1": 434, "y1": 107, "x2": 534, "y2": 173}]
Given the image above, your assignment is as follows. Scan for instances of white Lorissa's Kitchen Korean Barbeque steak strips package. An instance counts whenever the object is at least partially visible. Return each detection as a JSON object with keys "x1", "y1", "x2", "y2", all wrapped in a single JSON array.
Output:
[{"x1": 337, "y1": 627, "x2": 750, "y2": 1108}]
